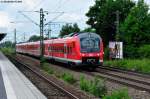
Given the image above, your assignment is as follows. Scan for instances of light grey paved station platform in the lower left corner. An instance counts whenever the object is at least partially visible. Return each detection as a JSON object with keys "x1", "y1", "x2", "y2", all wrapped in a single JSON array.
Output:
[{"x1": 0, "y1": 52, "x2": 47, "y2": 99}]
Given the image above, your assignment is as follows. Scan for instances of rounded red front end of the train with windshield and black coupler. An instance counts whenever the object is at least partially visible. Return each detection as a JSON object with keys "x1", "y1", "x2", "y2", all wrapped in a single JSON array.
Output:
[{"x1": 78, "y1": 33, "x2": 104, "y2": 66}]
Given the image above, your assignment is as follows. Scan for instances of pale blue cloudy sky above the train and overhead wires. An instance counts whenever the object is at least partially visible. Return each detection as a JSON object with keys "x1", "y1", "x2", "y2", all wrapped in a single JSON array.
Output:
[{"x1": 0, "y1": 0, "x2": 150, "y2": 42}]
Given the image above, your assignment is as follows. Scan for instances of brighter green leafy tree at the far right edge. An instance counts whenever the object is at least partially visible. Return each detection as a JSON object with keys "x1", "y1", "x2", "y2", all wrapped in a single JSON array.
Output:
[{"x1": 120, "y1": 0, "x2": 150, "y2": 46}]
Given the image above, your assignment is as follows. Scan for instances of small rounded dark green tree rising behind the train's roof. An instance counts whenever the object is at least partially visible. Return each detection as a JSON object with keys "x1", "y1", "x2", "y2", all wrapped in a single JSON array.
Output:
[{"x1": 59, "y1": 23, "x2": 80, "y2": 37}]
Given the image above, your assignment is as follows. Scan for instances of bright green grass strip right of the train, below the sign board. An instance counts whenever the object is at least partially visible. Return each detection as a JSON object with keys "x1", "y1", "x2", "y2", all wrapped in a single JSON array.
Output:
[{"x1": 104, "y1": 59, "x2": 150, "y2": 73}]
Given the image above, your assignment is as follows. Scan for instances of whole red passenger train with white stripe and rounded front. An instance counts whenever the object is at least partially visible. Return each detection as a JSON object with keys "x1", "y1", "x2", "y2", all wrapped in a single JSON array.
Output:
[{"x1": 16, "y1": 33, "x2": 104, "y2": 67}]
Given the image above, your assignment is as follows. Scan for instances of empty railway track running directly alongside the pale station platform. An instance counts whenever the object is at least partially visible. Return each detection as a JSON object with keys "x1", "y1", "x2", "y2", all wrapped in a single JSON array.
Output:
[{"x1": 8, "y1": 57, "x2": 80, "y2": 99}]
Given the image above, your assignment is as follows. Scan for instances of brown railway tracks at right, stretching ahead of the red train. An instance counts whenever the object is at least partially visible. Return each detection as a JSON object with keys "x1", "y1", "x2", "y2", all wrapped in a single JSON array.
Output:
[{"x1": 86, "y1": 67, "x2": 150, "y2": 92}]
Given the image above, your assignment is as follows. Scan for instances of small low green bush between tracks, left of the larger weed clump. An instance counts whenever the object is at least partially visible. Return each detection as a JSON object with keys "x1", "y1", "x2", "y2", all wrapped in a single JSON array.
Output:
[{"x1": 61, "y1": 73, "x2": 76, "y2": 84}]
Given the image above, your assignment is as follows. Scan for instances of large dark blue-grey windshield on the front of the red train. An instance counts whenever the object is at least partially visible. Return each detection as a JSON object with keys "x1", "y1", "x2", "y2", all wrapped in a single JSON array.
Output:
[{"x1": 80, "y1": 33, "x2": 100, "y2": 53}]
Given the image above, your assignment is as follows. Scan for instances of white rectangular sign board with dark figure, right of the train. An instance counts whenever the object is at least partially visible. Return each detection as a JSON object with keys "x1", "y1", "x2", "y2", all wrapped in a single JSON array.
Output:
[{"x1": 109, "y1": 42, "x2": 123, "y2": 59}]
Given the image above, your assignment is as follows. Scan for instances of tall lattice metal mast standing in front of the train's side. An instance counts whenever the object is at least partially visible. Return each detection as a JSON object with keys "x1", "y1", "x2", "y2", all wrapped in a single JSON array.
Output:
[{"x1": 40, "y1": 8, "x2": 44, "y2": 65}]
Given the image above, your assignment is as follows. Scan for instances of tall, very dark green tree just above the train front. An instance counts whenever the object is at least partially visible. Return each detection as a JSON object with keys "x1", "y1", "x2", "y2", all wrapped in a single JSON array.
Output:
[{"x1": 86, "y1": 0, "x2": 135, "y2": 45}]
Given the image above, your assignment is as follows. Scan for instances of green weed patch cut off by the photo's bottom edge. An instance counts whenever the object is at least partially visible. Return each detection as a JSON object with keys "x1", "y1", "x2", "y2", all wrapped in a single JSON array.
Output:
[{"x1": 102, "y1": 89, "x2": 131, "y2": 99}]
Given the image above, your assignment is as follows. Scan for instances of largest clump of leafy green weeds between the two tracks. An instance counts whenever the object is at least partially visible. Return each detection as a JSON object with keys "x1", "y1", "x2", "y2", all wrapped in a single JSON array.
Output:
[{"x1": 80, "y1": 76, "x2": 107, "y2": 97}]
